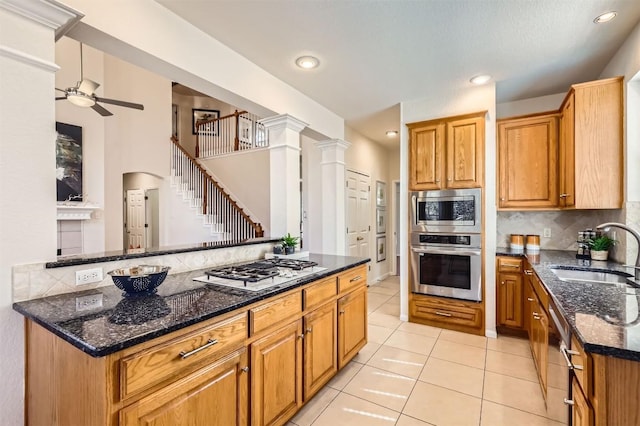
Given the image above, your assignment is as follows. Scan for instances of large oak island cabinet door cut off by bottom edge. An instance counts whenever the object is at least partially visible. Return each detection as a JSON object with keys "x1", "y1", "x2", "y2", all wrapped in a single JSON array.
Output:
[{"x1": 120, "y1": 348, "x2": 248, "y2": 426}]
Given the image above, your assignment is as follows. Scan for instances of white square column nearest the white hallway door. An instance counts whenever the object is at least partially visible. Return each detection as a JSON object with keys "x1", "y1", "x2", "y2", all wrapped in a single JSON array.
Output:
[{"x1": 315, "y1": 139, "x2": 351, "y2": 255}]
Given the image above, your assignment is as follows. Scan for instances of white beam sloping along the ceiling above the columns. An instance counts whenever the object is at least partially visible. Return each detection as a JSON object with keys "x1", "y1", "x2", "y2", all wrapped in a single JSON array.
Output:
[{"x1": 66, "y1": 0, "x2": 344, "y2": 144}]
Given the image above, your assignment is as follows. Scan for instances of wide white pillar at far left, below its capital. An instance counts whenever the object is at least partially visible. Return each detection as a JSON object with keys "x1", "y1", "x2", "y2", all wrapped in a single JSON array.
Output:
[{"x1": 0, "y1": 2, "x2": 66, "y2": 425}]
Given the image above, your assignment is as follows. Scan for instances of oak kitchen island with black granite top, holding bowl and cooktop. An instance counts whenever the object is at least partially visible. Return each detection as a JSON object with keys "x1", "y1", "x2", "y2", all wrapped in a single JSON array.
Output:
[{"x1": 14, "y1": 254, "x2": 369, "y2": 425}]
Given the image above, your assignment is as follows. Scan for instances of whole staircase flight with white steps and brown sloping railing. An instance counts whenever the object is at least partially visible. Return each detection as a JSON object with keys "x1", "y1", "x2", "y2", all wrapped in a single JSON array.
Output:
[{"x1": 171, "y1": 137, "x2": 264, "y2": 242}]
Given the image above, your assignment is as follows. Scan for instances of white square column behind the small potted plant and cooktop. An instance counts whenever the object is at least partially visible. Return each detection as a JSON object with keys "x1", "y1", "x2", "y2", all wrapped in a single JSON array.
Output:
[{"x1": 261, "y1": 114, "x2": 307, "y2": 238}]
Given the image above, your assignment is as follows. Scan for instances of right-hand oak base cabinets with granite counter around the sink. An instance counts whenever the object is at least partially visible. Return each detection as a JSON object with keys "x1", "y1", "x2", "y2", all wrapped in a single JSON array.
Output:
[{"x1": 497, "y1": 249, "x2": 640, "y2": 426}]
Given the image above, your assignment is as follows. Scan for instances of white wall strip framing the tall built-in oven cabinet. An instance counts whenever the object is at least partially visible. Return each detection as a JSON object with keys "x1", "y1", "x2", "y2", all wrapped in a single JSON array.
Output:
[{"x1": 400, "y1": 84, "x2": 496, "y2": 337}]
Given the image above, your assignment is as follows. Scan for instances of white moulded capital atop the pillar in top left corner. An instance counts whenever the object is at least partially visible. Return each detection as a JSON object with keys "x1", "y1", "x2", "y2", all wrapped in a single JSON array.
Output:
[{"x1": 0, "y1": 0, "x2": 84, "y2": 41}]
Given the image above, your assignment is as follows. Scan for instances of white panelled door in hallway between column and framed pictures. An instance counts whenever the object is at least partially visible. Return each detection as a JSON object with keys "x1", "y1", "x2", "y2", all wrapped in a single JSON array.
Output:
[{"x1": 346, "y1": 170, "x2": 371, "y2": 257}]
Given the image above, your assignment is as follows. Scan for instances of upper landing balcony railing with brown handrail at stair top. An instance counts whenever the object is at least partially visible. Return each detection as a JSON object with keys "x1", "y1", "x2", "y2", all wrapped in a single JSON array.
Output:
[{"x1": 196, "y1": 110, "x2": 269, "y2": 158}]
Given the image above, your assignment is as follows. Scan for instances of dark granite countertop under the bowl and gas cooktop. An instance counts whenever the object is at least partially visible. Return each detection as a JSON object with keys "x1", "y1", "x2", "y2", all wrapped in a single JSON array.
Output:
[{"x1": 13, "y1": 254, "x2": 370, "y2": 357}]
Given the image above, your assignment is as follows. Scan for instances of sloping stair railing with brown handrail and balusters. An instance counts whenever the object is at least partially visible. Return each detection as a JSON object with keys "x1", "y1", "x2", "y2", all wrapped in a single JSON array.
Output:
[{"x1": 171, "y1": 136, "x2": 264, "y2": 241}]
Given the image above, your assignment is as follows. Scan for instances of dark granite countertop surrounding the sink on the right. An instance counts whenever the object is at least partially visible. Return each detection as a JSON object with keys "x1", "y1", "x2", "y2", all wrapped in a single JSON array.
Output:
[{"x1": 496, "y1": 248, "x2": 640, "y2": 361}]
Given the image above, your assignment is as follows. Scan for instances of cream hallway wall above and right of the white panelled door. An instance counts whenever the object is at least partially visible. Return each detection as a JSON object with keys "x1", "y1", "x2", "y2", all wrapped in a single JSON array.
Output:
[{"x1": 345, "y1": 127, "x2": 394, "y2": 282}]
